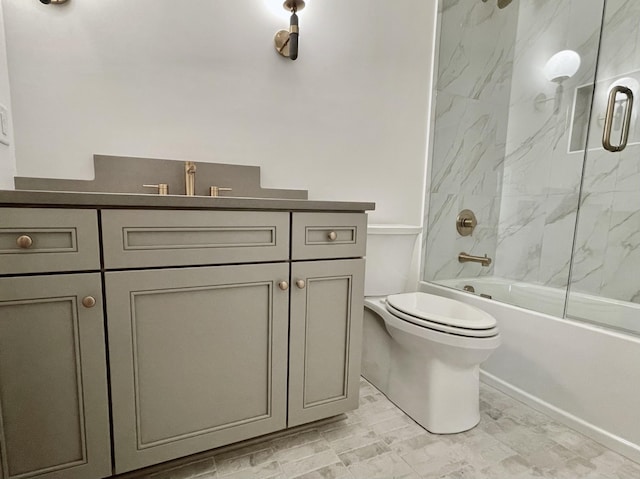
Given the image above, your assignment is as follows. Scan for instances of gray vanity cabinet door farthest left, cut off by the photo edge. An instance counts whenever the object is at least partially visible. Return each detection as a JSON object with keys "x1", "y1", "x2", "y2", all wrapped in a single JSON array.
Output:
[{"x1": 0, "y1": 273, "x2": 111, "y2": 479}]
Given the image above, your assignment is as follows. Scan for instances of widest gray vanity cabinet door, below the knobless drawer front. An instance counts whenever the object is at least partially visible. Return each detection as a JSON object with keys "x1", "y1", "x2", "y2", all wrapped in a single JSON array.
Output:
[{"x1": 105, "y1": 263, "x2": 289, "y2": 473}]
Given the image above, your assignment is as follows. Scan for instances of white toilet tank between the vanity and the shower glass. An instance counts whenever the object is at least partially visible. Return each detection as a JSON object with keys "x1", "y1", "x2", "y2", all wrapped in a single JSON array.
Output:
[{"x1": 364, "y1": 225, "x2": 422, "y2": 296}]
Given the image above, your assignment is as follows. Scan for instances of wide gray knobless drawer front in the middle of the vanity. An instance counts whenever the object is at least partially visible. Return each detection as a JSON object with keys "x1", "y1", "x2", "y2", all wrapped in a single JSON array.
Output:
[{"x1": 102, "y1": 210, "x2": 289, "y2": 269}]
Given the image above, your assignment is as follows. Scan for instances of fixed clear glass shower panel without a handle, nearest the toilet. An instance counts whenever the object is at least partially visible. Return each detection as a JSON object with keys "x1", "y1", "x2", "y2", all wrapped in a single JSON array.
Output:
[{"x1": 423, "y1": 0, "x2": 604, "y2": 317}]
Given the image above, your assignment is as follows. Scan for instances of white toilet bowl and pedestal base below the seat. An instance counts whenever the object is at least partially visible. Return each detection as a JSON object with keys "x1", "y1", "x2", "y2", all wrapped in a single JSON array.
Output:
[{"x1": 363, "y1": 298, "x2": 500, "y2": 434}]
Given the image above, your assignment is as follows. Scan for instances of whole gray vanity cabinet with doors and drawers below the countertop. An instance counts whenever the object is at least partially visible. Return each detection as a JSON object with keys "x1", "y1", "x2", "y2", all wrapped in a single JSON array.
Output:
[{"x1": 0, "y1": 199, "x2": 366, "y2": 479}]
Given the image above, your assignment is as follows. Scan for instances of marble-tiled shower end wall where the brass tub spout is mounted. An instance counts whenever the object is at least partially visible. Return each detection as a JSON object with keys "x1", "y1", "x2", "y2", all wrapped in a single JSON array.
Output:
[{"x1": 423, "y1": 0, "x2": 518, "y2": 280}]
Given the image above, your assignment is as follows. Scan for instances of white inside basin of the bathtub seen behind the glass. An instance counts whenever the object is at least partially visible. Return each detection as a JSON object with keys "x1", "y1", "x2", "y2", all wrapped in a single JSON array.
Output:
[{"x1": 438, "y1": 277, "x2": 640, "y2": 335}]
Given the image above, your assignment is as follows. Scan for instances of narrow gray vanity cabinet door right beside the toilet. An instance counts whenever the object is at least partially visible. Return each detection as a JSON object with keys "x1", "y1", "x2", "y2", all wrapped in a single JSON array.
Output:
[{"x1": 288, "y1": 259, "x2": 364, "y2": 427}]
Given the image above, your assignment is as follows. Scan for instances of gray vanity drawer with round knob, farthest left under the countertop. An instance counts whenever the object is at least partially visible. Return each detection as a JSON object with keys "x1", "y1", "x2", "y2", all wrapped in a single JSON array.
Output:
[{"x1": 0, "y1": 208, "x2": 100, "y2": 274}]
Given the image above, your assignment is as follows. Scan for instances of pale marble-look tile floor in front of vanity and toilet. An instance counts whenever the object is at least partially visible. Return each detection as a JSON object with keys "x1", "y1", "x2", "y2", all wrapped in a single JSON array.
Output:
[{"x1": 124, "y1": 379, "x2": 640, "y2": 479}]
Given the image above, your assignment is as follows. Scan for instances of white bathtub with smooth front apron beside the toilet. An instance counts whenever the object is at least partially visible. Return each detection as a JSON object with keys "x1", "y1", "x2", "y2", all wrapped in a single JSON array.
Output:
[{"x1": 418, "y1": 278, "x2": 640, "y2": 462}]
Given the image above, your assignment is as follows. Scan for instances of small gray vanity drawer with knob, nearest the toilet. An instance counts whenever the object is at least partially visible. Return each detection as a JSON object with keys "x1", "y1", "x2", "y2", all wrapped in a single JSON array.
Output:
[{"x1": 291, "y1": 213, "x2": 367, "y2": 260}]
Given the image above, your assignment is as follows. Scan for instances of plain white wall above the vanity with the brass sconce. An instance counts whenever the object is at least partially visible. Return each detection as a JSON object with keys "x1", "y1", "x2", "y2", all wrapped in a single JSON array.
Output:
[{"x1": 2, "y1": 0, "x2": 436, "y2": 224}]
